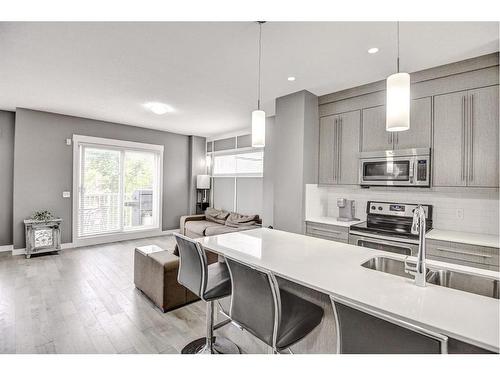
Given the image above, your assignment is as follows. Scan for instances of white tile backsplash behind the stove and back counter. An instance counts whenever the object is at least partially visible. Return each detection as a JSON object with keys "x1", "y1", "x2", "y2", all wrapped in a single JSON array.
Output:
[{"x1": 306, "y1": 184, "x2": 499, "y2": 234}]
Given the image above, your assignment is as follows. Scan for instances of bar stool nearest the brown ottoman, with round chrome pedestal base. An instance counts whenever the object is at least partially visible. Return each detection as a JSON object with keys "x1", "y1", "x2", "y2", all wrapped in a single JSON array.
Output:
[{"x1": 174, "y1": 233, "x2": 240, "y2": 354}]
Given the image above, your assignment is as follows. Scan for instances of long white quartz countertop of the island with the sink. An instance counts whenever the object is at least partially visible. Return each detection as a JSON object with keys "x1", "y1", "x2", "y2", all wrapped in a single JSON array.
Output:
[{"x1": 199, "y1": 228, "x2": 500, "y2": 352}]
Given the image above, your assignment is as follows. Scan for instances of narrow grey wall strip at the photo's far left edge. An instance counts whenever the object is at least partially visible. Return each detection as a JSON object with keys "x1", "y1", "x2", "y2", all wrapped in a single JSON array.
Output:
[{"x1": 0, "y1": 111, "x2": 15, "y2": 246}]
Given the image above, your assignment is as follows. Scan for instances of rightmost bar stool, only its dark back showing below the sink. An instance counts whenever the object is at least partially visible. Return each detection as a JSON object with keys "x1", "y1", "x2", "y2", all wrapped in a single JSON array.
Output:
[{"x1": 330, "y1": 296, "x2": 448, "y2": 354}]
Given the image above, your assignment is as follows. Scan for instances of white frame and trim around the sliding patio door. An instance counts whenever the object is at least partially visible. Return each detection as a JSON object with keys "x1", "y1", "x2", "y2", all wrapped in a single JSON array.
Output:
[{"x1": 72, "y1": 134, "x2": 164, "y2": 246}]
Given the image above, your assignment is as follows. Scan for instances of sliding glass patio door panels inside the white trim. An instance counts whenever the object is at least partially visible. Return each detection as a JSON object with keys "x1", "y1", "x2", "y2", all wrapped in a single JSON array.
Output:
[{"x1": 73, "y1": 136, "x2": 163, "y2": 244}]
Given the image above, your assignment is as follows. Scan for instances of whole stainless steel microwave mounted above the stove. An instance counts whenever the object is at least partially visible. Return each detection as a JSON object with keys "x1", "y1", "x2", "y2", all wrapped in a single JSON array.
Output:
[{"x1": 359, "y1": 148, "x2": 431, "y2": 187}]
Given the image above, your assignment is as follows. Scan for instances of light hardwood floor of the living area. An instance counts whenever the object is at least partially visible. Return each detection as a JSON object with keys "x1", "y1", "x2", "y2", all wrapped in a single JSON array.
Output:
[{"x1": 0, "y1": 236, "x2": 205, "y2": 353}]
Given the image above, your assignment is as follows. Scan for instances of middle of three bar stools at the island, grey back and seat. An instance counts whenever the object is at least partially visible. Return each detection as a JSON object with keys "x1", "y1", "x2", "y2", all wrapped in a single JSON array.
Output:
[{"x1": 226, "y1": 258, "x2": 323, "y2": 354}]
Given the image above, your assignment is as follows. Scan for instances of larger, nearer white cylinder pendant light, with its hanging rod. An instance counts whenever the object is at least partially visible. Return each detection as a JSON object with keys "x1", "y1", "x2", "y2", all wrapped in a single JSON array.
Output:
[{"x1": 385, "y1": 21, "x2": 410, "y2": 132}]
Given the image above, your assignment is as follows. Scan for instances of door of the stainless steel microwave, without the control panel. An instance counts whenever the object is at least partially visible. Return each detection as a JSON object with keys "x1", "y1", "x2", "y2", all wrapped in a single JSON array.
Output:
[{"x1": 359, "y1": 156, "x2": 415, "y2": 186}]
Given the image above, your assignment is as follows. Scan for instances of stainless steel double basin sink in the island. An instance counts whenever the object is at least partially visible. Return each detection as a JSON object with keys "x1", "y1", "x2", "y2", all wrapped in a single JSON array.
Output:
[{"x1": 361, "y1": 256, "x2": 500, "y2": 299}]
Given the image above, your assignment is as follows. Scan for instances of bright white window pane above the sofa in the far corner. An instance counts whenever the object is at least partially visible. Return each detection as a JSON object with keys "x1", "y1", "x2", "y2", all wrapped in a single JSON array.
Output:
[{"x1": 212, "y1": 150, "x2": 264, "y2": 177}]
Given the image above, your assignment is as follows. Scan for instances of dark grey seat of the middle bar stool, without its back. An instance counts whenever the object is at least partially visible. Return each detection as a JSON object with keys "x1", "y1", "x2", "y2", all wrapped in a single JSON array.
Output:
[{"x1": 276, "y1": 289, "x2": 323, "y2": 350}]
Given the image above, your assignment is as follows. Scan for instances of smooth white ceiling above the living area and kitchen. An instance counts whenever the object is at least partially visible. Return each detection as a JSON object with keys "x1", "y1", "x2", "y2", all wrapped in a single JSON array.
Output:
[{"x1": 0, "y1": 22, "x2": 499, "y2": 136}]
